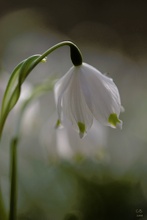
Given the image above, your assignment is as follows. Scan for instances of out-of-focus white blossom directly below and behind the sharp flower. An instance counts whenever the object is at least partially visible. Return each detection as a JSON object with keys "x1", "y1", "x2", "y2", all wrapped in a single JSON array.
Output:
[{"x1": 40, "y1": 114, "x2": 108, "y2": 160}]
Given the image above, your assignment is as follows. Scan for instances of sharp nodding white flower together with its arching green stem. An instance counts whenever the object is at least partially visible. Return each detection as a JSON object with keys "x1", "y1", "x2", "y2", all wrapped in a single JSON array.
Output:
[{"x1": 0, "y1": 41, "x2": 122, "y2": 137}]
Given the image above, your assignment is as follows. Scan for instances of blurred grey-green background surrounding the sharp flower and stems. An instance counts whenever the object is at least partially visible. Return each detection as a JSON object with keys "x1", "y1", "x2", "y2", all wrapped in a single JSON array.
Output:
[{"x1": 0, "y1": 0, "x2": 147, "y2": 220}]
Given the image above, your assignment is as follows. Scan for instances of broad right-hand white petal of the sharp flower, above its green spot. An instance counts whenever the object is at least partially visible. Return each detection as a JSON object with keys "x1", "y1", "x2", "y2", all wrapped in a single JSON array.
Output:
[{"x1": 80, "y1": 63, "x2": 121, "y2": 125}]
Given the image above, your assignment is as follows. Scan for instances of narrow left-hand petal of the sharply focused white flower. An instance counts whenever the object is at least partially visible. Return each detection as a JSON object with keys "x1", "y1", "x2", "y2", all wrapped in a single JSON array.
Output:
[{"x1": 54, "y1": 67, "x2": 74, "y2": 120}]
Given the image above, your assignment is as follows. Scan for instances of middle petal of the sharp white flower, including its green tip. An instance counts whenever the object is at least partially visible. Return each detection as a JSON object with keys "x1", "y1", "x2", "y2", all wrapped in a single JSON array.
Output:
[{"x1": 63, "y1": 67, "x2": 93, "y2": 137}]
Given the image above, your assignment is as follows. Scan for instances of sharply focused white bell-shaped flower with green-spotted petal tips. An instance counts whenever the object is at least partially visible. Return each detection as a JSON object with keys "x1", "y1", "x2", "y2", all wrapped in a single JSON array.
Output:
[{"x1": 54, "y1": 63, "x2": 122, "y2": 137}]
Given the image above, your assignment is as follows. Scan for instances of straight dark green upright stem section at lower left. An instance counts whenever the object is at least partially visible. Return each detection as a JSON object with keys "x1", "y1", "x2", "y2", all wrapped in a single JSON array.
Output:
[{"x1": 9, "y1": 138, "x2": 18, "y2": 220}]
